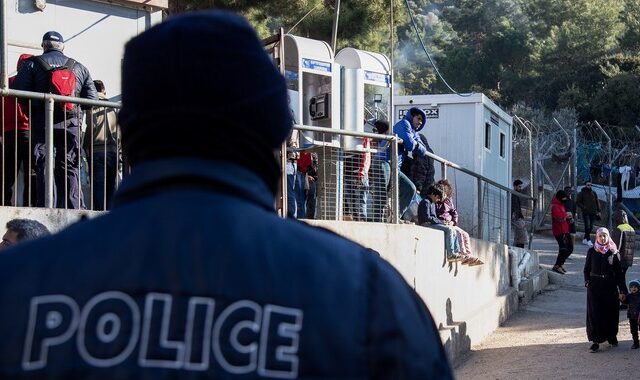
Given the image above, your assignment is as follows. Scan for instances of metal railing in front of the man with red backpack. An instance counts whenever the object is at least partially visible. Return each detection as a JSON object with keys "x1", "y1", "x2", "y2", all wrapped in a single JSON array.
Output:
[{"x1": 0, "y1": 88, "x2": 123, "y2": 210}]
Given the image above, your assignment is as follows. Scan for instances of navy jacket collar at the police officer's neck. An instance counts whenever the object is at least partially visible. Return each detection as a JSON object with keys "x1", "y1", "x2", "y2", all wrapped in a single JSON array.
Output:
[{"x1": 114, "y1": 158, "x2": 275, "y2": 211}]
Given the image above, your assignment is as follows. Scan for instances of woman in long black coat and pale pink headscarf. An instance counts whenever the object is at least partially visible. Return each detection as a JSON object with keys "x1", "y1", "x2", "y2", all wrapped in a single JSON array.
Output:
[{"x1": 584, "y1": 227, "x2": 627, "y2": 352}]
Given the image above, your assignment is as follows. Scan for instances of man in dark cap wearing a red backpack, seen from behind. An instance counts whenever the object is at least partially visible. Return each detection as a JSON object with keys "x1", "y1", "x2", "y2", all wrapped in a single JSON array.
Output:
[{"x1": 13, "y1": 31, "x2": 98, "y2": 209}]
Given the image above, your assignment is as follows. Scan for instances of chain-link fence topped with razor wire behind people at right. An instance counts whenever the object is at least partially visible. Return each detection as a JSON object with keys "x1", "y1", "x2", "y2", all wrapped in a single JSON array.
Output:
[{"x1": 513, "y1": 110, "x2": 640, "y2": 230}]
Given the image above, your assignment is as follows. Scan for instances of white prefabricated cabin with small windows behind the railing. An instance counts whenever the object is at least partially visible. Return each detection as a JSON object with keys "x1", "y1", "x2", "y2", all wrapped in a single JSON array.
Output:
[{"x1": 394, "y1": 94, "x2": 511, "y2": 236}]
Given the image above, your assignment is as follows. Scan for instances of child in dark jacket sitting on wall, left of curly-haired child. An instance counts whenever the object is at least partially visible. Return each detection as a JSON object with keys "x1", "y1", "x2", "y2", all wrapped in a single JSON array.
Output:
[{"x1": 418, "y1": 185, "x2": 464, "y2": 262}]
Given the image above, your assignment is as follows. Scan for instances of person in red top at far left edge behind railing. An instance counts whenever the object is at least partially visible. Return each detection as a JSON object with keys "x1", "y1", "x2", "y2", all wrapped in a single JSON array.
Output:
[{"x1": 2, "y1": 54, "x2": 36, "y2": 206}]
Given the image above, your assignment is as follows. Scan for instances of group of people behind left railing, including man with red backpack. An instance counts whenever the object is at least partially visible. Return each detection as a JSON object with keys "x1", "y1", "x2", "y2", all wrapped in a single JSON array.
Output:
[{"x1": 0, "y1": 31, "x2": 122, "y2": 210}]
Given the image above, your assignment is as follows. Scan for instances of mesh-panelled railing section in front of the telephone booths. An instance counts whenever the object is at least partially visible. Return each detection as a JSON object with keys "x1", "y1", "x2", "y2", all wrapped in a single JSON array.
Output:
[{"x1": 278, "y1": 125, "x2": 401, "y2": 223}]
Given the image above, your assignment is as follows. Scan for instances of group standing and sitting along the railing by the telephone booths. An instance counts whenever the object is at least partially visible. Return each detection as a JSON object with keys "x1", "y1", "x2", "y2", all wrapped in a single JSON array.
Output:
[{"x1": 286, "y1": 107, "x2": 483, "y2": 266}]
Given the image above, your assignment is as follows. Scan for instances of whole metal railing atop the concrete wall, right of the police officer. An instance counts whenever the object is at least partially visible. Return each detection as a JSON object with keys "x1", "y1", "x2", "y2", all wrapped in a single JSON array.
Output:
[{"x1": 279, "y1": 125, "x2": 537, "y2": 243}]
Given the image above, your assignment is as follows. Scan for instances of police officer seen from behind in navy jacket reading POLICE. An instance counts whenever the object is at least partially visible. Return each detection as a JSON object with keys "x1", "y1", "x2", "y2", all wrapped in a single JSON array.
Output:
[{"x1": 0, "y1": 11, "x2": 453, "y2": 379}]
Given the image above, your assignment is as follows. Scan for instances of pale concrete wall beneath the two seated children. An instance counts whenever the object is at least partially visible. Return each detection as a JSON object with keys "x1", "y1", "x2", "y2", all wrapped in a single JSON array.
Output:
[{"x1": 307, "y1": 220, "x2": 518, "y2": 362}]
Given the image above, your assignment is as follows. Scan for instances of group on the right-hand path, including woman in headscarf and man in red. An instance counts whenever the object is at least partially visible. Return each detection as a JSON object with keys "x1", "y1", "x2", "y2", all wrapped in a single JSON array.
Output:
[{"x1": 540, "y1": 181, "x2": 640, "y2": 352}]
